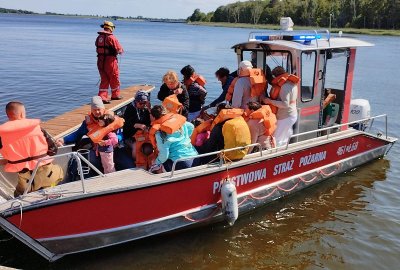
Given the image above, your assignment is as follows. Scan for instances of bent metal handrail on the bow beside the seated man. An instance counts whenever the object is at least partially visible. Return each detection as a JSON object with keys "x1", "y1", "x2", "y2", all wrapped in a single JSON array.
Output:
[{"x1": 22, "y1": 152, "x2": 104, "y2": 196}]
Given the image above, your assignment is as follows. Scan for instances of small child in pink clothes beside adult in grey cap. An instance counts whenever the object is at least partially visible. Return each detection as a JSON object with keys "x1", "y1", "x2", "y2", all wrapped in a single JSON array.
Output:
[{"x1": 96, "y1": 114, "x2": 118, "y2": 173}]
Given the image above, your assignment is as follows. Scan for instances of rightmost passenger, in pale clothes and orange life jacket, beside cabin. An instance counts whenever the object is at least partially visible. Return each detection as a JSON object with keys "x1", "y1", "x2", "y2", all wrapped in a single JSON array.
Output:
[{"x1": 264, "y1": 66, "x2": 300, "y2": 147}]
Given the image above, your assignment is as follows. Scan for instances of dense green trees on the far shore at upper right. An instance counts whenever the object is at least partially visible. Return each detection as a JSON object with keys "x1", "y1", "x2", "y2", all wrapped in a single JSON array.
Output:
[{"x1": 188, "y1": 0, "x2": 400, "y2": 29}]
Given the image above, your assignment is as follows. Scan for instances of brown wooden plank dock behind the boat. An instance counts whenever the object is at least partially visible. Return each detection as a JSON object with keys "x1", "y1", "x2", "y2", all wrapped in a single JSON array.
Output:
[{"x1": 41, "y1": 85, "x2": 154, "y2": 139}]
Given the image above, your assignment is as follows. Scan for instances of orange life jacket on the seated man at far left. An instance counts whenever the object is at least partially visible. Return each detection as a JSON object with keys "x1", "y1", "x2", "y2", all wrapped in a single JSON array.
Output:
[{"x1": 0, "y1": 119, "x2": 52, "y2": 172}]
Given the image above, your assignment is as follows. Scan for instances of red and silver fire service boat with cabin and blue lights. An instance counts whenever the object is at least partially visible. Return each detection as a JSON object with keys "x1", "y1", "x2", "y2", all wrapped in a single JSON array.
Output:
[{"x1": 0, "y1": 28, "x2": 397, "y2": 261}]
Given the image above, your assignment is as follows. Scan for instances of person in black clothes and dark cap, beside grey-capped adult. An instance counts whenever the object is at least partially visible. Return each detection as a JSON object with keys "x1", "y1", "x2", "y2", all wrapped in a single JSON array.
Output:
[{"x1": 123, "y1": 91, "x2": 151, "y2": 159}]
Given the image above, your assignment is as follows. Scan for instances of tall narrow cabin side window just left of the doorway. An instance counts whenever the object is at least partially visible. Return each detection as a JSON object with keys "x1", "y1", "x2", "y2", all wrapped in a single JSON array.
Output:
[{"x1": 301, "y1": 51, "x2": 317, "y2": 102}]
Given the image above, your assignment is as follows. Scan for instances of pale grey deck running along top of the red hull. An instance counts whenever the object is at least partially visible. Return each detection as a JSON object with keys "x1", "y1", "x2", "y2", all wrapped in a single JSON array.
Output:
[{"x1": 0, "y1": 129, "x2": 362, "y2": 213}]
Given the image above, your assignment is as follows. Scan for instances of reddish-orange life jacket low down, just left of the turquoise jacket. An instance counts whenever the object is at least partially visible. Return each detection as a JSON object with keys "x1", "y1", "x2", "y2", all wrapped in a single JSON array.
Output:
[{"x1": 135, "y1": 130, "x2": 158, "y2": 170}]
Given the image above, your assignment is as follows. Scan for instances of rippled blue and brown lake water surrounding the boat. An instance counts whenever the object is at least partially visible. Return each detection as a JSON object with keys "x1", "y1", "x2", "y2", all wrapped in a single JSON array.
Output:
[{"x1": 0, "y1": 15, "x2": 400, "y2": 269}]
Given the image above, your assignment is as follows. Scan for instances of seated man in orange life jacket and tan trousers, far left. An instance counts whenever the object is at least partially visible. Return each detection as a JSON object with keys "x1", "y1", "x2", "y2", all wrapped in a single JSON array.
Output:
[{"x1": 0, "y1": 101, "x2": 64, "y2": 195}]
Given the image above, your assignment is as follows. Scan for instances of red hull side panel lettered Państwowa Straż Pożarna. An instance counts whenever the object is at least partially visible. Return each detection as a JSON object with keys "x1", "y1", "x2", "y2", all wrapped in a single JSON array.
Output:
[{"x1": 8, "y1": 135, "x2": 385, "y2": 239}]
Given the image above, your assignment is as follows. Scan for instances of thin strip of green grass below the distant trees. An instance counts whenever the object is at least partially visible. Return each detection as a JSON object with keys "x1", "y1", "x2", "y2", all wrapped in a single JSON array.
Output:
[{"x1": 189, "y1": 22, "x2": 400, "y2": 36}]
